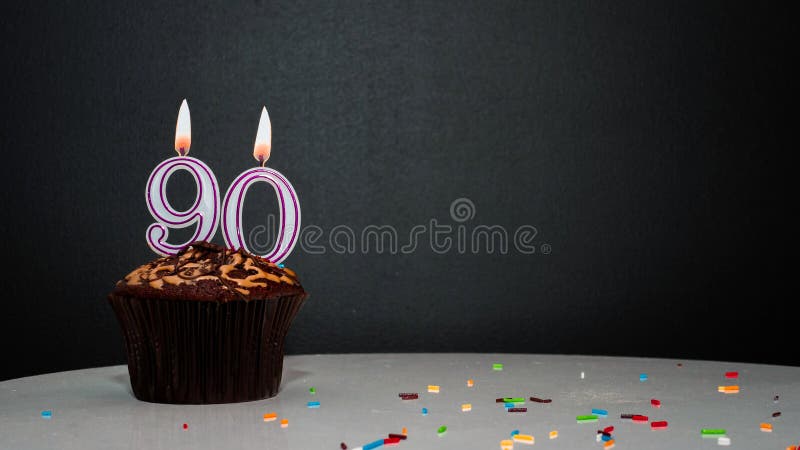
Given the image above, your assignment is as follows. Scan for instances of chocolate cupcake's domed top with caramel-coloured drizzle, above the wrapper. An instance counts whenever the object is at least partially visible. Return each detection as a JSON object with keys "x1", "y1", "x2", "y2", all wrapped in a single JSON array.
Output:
[{"x1": 112, "y1": 241, "x2": 305, "y2": 302}]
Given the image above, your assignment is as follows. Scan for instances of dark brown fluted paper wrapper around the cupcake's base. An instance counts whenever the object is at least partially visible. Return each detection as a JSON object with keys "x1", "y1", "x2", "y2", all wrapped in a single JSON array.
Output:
[{"x1": 109, "y1": 294, "x2": 306, "y2": 404}]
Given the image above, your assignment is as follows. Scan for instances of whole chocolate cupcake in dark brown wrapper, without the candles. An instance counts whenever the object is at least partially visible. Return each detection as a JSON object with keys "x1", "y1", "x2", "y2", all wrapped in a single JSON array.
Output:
[{"x1": 108, "y1": 242, "x2": 307, "y2": 404}]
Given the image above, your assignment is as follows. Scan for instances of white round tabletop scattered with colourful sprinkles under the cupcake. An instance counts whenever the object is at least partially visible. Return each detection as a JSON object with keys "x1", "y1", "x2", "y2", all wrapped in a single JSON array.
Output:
[{"x1": 0, "y1": 354, "x2": 800, "y2": 450}]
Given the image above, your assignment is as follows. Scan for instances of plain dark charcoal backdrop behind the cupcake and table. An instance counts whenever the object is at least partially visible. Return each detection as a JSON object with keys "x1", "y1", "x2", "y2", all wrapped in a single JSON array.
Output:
[{"x1": 0, "y1": 0, "x2": 800, "y2": 379}]
